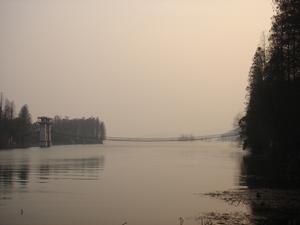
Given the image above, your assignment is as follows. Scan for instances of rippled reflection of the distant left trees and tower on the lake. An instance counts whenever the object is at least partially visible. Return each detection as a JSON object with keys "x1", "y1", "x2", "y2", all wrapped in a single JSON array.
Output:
[{"x1": 0, "y1": 155, "x2": 105, "y2": 192}]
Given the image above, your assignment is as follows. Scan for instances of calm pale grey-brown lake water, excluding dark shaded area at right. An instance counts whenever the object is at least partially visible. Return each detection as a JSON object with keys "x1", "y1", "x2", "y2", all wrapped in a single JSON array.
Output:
[{"x1": 0, "y1": 142, "x2": 248, "y2": 225}]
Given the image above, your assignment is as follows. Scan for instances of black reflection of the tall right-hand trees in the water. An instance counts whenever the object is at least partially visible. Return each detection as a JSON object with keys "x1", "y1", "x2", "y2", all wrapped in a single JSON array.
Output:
[{"x1": 240, "y1": 154, "x2": 300, "y2": 225}]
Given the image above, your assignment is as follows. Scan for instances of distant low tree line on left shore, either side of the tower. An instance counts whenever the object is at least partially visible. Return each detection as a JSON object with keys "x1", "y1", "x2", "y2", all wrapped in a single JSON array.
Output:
[{"x1": 0, "y1": 93, "x2": 106, "y2": 149}]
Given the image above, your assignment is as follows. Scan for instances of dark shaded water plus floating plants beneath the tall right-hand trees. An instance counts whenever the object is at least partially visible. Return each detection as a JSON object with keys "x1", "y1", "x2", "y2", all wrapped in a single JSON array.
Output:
[{"x1": 199, "y1": 154, "x2": 300, "y2": 225}]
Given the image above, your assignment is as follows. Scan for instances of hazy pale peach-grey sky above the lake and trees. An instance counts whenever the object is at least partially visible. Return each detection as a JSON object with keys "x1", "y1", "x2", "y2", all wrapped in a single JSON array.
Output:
[{"x1": 0, "y1": 0, "x2": 273, "y2": 136}]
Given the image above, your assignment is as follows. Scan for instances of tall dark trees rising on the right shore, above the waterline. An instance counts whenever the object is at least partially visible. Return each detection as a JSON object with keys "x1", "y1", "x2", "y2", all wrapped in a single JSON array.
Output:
[{"x1": 239, "y1": 0, "x2": 300, "y2": 155}]
